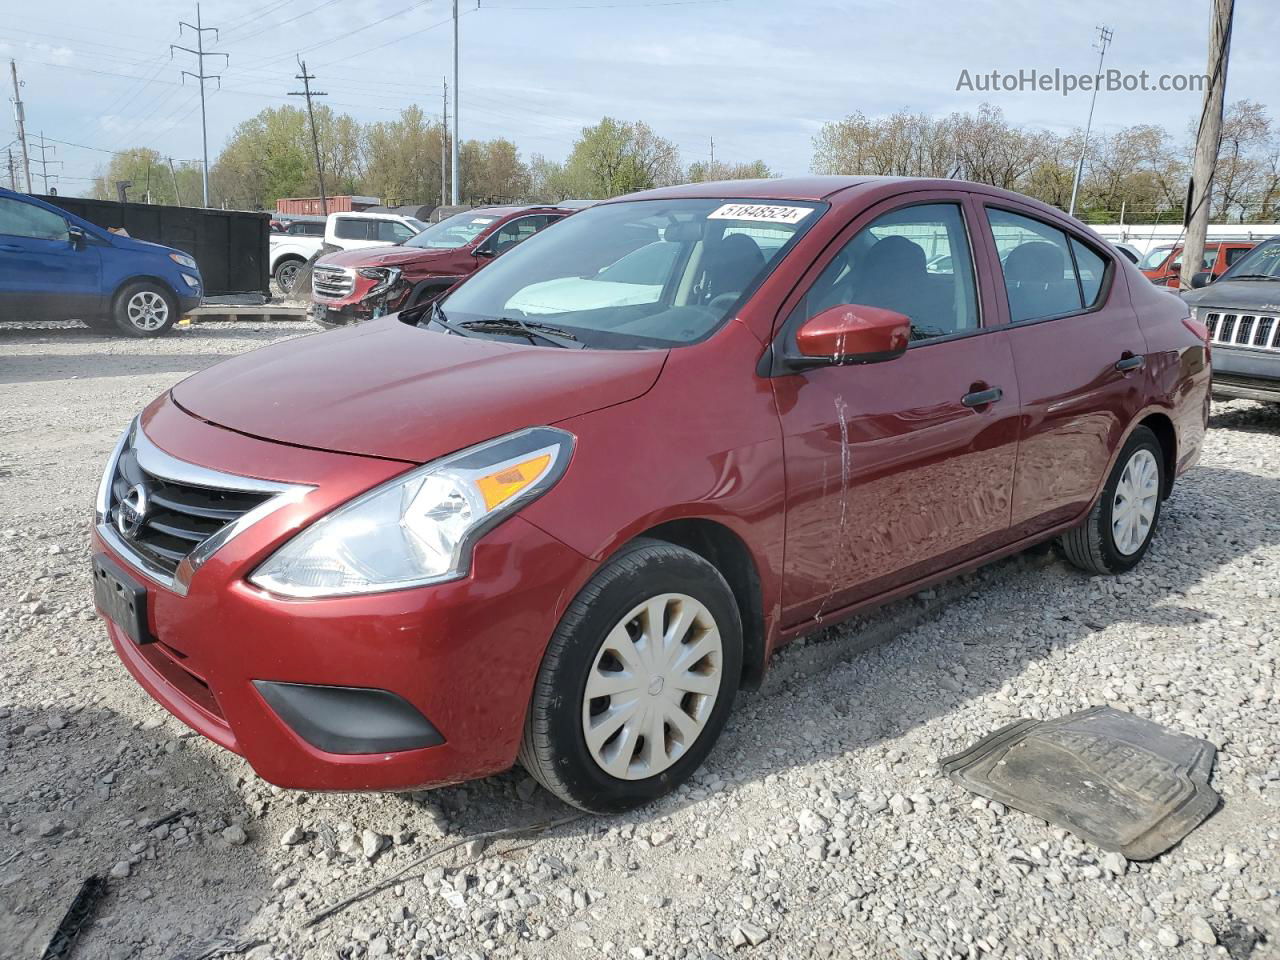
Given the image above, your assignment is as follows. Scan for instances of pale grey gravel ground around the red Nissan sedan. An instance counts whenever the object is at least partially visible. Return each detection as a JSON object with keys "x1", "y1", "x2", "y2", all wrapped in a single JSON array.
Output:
[{"x1": 0, "y1": 324, "x2": 1280, "y2": 960}]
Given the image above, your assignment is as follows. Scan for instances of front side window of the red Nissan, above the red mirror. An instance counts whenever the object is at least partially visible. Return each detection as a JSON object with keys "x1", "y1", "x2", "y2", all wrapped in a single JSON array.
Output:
[{"x1": 788, "y1": 204, "x2": 978, "y2": 340}]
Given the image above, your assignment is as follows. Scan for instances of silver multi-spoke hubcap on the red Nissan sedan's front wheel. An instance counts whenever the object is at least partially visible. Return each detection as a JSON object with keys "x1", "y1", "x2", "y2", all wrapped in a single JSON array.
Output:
[{"x1": 582, "y1": 594, "x2": 724, "y2": 780}]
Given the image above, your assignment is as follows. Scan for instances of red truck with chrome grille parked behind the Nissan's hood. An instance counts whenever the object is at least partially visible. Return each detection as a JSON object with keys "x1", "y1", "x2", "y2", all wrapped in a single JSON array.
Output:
[{"x1": 310, "y1": 206, "x2": 573, "y2": 326}]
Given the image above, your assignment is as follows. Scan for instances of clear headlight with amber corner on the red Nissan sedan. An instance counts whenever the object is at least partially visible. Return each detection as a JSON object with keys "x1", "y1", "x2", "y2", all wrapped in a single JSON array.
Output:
[{"x1": 250, "y1": 426, "x2": 573, "y2": 596}]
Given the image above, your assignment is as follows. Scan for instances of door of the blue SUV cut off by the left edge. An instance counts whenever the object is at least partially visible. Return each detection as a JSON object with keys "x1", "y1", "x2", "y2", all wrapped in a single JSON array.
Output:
[{"x1": 0, "y1": 197, "x2": 102, "y2": 320}]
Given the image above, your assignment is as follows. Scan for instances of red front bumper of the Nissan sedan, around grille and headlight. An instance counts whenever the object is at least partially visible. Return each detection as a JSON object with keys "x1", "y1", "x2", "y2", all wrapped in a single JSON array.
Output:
[{"x1": 93, "y1": 401, "x2": 594, "y2": 790}]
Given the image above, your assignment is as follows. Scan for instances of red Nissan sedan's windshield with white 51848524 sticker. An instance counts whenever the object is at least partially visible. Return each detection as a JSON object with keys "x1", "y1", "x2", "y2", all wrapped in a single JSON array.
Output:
[{"x1": 437, "y1": 198, "x2": 820, "y2": 349}]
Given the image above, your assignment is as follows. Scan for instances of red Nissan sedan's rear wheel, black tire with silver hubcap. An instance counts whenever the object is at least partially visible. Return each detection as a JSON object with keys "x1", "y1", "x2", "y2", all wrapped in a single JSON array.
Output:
[{"x1": 1062, "y1": 426, "x2": 1165, "y2": 575}]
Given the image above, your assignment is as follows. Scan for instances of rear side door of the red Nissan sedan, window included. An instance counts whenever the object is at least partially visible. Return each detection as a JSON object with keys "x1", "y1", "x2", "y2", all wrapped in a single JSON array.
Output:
[{"x1": 983, "y1": 200, "x2": 1147, "y2": 538}]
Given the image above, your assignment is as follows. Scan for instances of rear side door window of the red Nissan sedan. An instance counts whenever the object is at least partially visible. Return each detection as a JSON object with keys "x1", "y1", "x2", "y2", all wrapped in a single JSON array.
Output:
[{"x1": 987, "y1": 207, "x2": 1107, "y2": 324}]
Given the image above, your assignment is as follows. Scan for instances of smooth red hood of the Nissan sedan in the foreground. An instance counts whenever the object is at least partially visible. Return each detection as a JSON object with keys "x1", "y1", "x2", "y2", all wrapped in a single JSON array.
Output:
[{"x1": 172, "y1": 315, "x2": 667, "y2": 463}]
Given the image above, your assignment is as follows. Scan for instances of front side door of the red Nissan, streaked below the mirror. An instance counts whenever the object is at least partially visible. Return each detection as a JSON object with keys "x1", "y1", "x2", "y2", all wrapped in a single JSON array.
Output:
[{"x1": 773, "y1": 199, "x2": 1019, "y2": 626}]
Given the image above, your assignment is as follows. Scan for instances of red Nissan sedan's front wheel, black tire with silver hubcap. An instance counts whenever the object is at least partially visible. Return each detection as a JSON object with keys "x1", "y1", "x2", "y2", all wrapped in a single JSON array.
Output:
[{"x1": 520, "y1": 539, "x2": 742, "y2": 813}]
